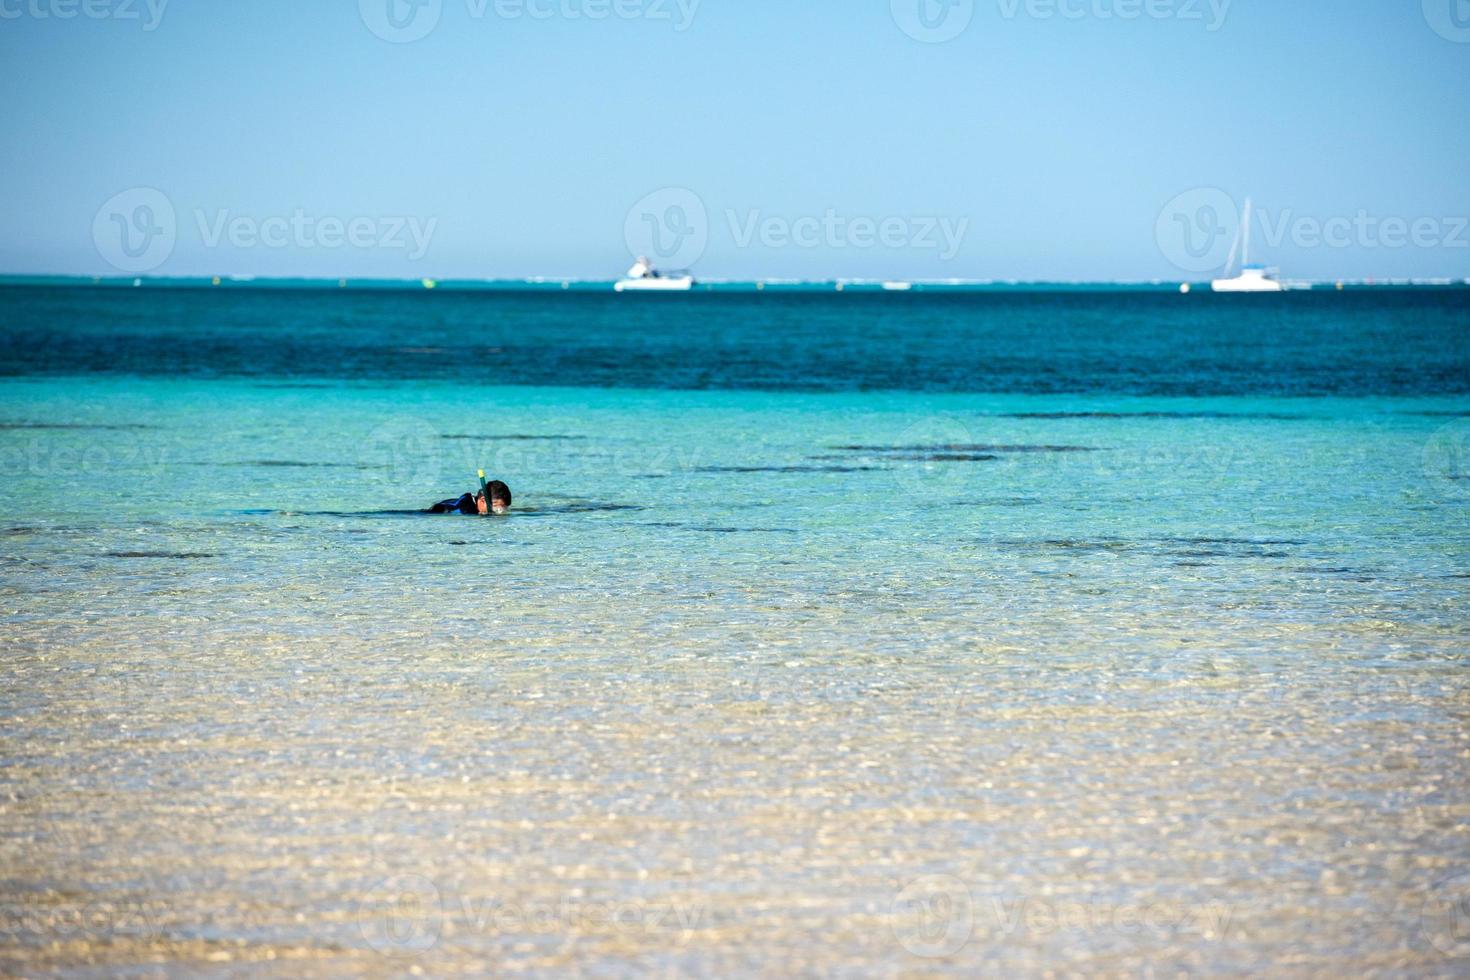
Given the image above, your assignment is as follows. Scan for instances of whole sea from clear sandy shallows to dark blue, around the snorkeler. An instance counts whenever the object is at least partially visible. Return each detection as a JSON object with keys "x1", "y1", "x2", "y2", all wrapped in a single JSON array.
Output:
[{"x1": 0, "y1": 291, "x2": 1470, "y2": 976}]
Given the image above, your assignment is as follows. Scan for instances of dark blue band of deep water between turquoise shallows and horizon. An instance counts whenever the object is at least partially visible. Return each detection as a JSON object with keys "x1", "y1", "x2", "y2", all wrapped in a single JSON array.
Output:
[{"x1": 0, "y1": 287, "x2": 1470, "y2": 397}]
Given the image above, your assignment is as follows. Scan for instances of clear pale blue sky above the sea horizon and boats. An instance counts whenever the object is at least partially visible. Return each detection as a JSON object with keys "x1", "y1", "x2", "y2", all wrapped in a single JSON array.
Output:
[{"x1": 0, "y1": 0, "x2": 1470, "y2": 281}]
